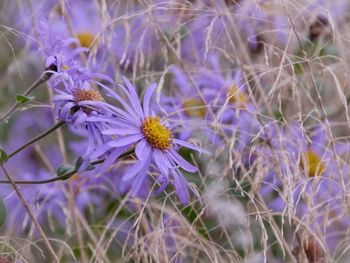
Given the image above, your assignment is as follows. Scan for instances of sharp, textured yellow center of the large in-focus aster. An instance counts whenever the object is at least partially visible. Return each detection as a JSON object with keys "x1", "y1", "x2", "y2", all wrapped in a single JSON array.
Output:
[{"x1": 141, "y1": 116, "x2": 173, "y2": 150}]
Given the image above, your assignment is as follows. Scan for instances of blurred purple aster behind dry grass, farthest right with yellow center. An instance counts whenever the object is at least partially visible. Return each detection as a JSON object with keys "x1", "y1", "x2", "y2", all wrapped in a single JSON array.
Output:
[{"x1": 257, "y1": 123, "x2": 329, "y2": 211}]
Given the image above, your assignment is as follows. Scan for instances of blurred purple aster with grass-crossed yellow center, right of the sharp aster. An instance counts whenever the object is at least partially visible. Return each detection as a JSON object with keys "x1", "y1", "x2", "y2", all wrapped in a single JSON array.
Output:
[{"x1": 194, "y1": 55, "x2": 260, "y2": 155}]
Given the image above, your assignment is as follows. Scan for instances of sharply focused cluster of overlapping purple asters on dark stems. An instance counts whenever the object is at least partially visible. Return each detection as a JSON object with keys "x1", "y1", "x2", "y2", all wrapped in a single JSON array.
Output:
[{"x1": 37, "y1": 20, "x2": 209, "y2": 204}]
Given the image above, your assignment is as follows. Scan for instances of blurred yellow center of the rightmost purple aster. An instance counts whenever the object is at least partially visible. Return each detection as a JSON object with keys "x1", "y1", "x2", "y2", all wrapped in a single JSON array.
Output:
[{"x1": 300, "y1": 150, "x2": 326, "y2": 177}]
